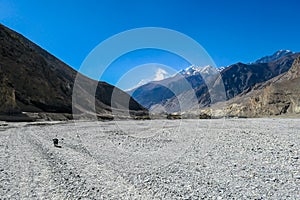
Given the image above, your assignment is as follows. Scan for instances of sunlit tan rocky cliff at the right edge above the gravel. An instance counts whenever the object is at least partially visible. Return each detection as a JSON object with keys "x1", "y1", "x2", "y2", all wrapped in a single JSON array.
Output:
[{"x1": 225, "y1": 57, "x2": 300, "y2": 117}]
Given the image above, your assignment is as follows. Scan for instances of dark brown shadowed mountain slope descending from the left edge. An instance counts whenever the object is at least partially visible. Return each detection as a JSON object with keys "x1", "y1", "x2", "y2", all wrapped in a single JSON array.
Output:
[{"x1": 0, "y1": 25, "x2": 146, "y2": 120}]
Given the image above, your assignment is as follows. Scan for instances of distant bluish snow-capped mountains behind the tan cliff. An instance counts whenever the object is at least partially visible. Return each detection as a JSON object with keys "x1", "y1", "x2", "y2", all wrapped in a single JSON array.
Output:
[{"x1": 131, "y1": 51, "x2": 300, "y2": 112}]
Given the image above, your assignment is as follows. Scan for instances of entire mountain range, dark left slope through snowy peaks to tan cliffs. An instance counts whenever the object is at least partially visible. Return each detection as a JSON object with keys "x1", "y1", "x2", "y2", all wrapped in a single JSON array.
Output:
[{"x1": 0, "y1": 24, "x2": 300, "y2": 121}]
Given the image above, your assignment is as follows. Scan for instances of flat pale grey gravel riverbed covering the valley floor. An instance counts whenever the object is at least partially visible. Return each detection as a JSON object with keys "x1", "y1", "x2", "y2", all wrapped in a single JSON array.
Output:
[{"x1": 0, "y1": 119, "x2": 300, "y2": 199}]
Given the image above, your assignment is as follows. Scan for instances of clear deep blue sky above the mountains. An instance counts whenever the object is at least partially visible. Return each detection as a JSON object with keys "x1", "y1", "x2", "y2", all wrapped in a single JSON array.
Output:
[{"x1": 0, "y1": 0, "x2": 300, "y2": 89}]
